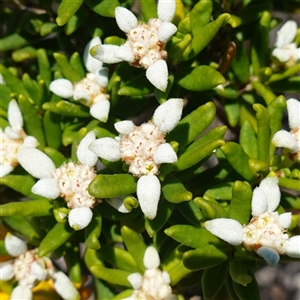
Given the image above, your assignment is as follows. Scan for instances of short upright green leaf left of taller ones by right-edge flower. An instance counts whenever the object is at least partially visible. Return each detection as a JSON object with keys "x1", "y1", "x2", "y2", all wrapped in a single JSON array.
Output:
[{"x1": 240, "y1": 120, "x2": 258, "y2": 158}]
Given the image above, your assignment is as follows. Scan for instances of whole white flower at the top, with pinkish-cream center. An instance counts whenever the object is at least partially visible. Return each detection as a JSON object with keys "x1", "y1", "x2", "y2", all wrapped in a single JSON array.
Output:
[{"x1": 91, "y1": 0, "x2": 177, "y2": 91}]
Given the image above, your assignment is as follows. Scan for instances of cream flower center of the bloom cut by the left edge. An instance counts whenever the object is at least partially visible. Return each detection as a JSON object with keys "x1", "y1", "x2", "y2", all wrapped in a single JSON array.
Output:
[{"x1": 0, "y1": 130, "x2": 26, "y2": 167}]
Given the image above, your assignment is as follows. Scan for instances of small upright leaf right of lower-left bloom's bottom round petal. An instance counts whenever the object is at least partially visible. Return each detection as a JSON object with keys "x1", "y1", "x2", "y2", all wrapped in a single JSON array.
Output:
[{"x1": 84, "y1": 210, "x2": 102, "y2": 250}]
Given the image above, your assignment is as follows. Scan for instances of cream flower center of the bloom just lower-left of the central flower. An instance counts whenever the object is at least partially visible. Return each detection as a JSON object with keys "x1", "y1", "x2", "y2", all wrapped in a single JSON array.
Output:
[{"x1": 53, "y1": 162, "x2": 98, "y2": 208}]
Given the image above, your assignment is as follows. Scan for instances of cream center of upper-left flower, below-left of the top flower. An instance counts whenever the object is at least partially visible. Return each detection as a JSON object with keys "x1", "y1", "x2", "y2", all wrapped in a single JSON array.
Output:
[{"x1": 73, "y1": 73, "x2": 109, "y2": 107}]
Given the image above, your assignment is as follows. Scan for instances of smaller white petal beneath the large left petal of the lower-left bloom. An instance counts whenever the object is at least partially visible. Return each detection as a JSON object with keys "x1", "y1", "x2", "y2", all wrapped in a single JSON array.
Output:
[{"x1": 31, "y1": 177, "x2": 60, "y2": 199}]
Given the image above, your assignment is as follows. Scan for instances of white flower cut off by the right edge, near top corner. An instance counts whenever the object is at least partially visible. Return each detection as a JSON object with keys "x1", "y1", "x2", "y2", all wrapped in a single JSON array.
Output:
[{"x1": 272, "y1": 20, "x2": 300, "y2": 67}]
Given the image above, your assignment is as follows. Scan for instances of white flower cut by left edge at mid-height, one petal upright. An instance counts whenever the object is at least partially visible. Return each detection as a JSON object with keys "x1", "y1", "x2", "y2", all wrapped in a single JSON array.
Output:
[{"x1": 0, "y1": 100, "x2": 38, "y2": 177}]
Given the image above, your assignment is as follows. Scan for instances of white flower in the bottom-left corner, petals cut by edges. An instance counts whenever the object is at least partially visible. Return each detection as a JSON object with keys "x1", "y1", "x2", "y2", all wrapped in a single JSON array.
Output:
[{"x1": 0, "y1": 233, "x2": 80, "y2": 300}]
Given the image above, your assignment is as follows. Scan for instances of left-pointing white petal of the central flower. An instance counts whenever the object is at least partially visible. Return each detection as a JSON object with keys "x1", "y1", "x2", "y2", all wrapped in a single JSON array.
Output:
[{"x1": 89, "y1": 137, "x2": 121, "y2": 161}]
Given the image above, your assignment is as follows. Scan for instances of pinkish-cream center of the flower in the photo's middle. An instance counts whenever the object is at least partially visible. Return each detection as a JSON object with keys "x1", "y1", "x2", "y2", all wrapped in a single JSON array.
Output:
[{"x1": 119, "y1": 121, "x2": 165, "y2": 177}]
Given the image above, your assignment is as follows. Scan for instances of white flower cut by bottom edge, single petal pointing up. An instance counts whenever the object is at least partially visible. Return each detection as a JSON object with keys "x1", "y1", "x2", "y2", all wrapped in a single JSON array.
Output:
[{"x1": 123, "y1": 246, "x2": 174, "y2": 300}]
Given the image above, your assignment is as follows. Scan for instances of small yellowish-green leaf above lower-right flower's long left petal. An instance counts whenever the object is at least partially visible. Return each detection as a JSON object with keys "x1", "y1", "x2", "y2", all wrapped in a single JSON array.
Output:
[{"x1": 194, "y1": 197, "x2": 228, "y2": 219}]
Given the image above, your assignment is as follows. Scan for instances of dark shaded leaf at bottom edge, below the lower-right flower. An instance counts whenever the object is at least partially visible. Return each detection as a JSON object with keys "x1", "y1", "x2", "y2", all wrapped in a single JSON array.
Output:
[{"x1": 201, "y1": 261, "x2": 228, "y2": 299}]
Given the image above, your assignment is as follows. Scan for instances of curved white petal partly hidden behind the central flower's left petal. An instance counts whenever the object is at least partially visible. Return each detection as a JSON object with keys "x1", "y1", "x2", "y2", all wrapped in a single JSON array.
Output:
[{"x1": 76, "y1": 131, "x2": 98, "y2": 167}]
